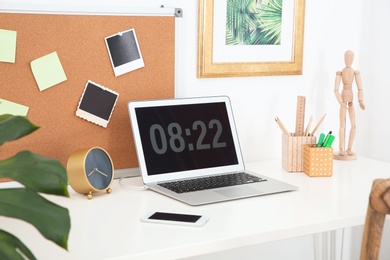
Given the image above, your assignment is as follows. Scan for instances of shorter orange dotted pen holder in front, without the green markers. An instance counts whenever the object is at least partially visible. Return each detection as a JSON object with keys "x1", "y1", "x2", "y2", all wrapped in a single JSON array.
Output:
[{"x1": 303, "y1": 145, "x2": 333, "y2": 177}]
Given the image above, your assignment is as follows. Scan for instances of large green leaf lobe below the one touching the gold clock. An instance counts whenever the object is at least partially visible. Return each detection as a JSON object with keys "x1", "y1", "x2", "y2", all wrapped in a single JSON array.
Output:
[{"x1": 0, "y1": 188, "x2": 70, "y2": 249}]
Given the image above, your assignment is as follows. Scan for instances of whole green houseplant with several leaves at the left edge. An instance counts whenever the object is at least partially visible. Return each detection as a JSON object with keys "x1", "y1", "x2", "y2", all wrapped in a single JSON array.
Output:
[{"x1": 0, "y1": 115, "x2": 70, "y2": 259}]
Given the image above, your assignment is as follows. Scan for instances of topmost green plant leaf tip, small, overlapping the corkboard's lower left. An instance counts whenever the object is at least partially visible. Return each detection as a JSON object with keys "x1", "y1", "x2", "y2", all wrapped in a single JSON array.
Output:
[{"x1": 0, "y1": 114, "x2": 39, "y2": 145}]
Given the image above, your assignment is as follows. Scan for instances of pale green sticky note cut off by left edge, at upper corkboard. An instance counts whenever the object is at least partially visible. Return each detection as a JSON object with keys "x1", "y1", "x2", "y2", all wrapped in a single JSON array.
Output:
[{"x1": 0, "y1": 29, "x2": 16, "y2": 63}]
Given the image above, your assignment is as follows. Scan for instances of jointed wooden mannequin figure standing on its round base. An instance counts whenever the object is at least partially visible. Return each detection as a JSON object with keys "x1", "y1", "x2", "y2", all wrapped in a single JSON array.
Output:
[{"x1": 334, "y1": 50, "x2": 366, "y2": 160}]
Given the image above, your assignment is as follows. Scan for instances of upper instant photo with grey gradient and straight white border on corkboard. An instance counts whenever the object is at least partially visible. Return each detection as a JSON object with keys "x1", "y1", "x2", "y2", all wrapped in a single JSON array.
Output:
[{"x1": 105, "y1": 29, "x2": 145, "y2": 77}]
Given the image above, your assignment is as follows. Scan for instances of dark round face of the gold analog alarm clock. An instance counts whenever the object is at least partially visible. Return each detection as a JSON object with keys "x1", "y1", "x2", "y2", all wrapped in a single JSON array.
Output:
[{"x1": 85, "y1": 148, "x2": 113, "y2": 190}]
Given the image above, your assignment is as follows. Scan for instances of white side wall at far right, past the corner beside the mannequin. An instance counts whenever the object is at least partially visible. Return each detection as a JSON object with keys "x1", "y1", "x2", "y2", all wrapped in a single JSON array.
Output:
[{"x1": 359, "y1": 0, "x2": 390, "y2": 161}]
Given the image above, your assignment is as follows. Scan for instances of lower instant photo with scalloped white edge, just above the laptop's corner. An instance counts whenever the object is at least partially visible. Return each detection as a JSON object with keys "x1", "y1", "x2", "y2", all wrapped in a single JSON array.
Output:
[{"x1": 76, "y1": 81, "x2": 119, "y2": 127}]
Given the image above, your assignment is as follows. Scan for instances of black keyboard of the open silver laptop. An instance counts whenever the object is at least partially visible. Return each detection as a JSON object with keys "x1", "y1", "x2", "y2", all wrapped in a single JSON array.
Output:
[{"x1": 158, "y1": 172, "x2": 267, "y2": 193}]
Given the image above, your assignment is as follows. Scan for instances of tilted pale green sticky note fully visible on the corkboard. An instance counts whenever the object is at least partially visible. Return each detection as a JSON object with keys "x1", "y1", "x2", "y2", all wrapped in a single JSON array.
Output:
[{"x1": 31, "y1": 52, "x2": 67, "y2": 91}]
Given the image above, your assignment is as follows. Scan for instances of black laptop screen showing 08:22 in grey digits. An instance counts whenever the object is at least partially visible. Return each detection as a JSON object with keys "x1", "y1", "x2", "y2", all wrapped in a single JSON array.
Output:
[{"x1": 135, "y1": 102, "x2": 238, "y2": 175}]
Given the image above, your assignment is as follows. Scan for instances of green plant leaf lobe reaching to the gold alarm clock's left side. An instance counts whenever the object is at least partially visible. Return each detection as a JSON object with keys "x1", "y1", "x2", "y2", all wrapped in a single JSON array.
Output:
[{"x1": 0, "y1": 151, "x2": 69, "y2": 197}]
